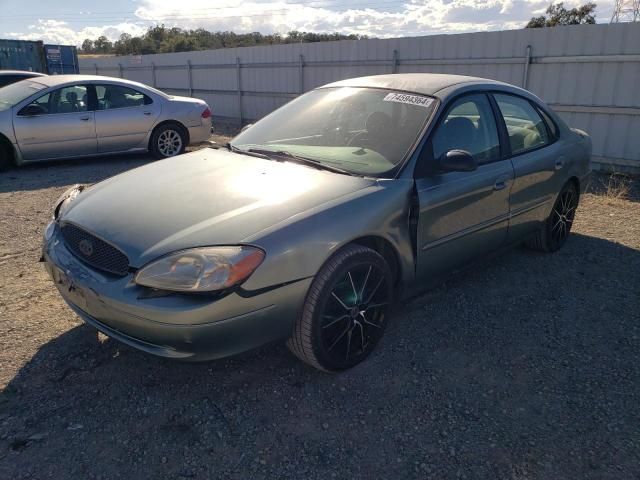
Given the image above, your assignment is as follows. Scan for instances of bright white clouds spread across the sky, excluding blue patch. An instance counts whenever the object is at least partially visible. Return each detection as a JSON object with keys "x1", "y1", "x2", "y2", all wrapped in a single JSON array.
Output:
[{"x1": 2, "y1": 0, "x2": 614, "y2": 45}]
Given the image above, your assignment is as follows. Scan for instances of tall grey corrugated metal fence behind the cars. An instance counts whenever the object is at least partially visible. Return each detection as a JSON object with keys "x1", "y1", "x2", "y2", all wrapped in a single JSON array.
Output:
[{"x1": 80, "y1": 23, "x2": 640, "y2": 172}]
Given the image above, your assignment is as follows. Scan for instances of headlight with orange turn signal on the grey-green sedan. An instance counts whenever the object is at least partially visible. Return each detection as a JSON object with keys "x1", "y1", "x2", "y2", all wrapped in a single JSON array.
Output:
[{"x1": 135, "y1": 246, "x2": 264, "y2": 292}]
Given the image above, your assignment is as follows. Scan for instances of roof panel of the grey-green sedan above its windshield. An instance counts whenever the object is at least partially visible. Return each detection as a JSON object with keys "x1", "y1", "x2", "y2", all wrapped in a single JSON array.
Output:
[{"x1": 320, "y1": 73, "x2": 507, "y2": 97}]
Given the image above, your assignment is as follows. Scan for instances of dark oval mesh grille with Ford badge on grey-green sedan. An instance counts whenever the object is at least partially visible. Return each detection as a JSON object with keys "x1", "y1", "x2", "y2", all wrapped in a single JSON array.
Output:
[{"x1": 61, "y1": 223, "x2": 129, "y2": 277}]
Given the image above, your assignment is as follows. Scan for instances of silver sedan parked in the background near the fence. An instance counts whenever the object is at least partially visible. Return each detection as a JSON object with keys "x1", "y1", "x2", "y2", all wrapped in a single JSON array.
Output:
[{"x1": 0, "y1": 75, "x2": 211, "y2": 169}]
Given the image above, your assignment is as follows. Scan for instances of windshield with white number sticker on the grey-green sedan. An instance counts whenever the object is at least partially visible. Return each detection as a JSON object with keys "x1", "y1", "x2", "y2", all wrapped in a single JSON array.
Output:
[{"x1": 231, "y1": 87, "x2": 435, "y2": 176}]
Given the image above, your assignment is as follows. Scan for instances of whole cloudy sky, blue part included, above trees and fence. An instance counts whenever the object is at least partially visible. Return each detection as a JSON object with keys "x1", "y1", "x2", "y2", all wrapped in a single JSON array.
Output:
[{"x1": 0, "y1": 0, "x2": 615, "y2": 45}]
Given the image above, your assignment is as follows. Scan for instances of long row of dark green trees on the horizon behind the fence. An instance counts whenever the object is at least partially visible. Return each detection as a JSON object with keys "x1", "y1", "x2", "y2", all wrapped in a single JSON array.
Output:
[{"x1": 80, "y1": 25, "x2": 368, "y2": 55}]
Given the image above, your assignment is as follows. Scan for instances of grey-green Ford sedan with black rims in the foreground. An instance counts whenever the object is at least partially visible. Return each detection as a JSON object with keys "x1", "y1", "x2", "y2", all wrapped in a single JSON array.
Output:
[{"x1": 43, "y1": 74, "x2": 591, "y2": 372}]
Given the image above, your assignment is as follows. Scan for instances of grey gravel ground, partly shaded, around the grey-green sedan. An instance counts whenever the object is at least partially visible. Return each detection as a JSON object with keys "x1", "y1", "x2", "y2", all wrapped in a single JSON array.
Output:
[{"x1": 0, "y1": 143, "x2": 640, "y2": 480}]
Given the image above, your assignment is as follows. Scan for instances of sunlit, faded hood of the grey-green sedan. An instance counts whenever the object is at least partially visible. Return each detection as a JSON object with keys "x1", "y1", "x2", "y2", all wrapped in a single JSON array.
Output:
[{"x1": 60, "y1": 149, "x2": 375, "y2": 267}]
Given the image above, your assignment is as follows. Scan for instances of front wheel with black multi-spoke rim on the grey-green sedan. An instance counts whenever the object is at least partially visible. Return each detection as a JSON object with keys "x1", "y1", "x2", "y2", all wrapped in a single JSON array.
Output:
[{"x1": 287, "y1": 245, "x2": 392, "y2": 372}]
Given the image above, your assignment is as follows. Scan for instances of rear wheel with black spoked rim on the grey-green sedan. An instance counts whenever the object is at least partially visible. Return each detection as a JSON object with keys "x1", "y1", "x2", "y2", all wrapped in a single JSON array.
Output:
[{"x1": 526, "y1": 181, "x2": 579, "y2": 253}]
